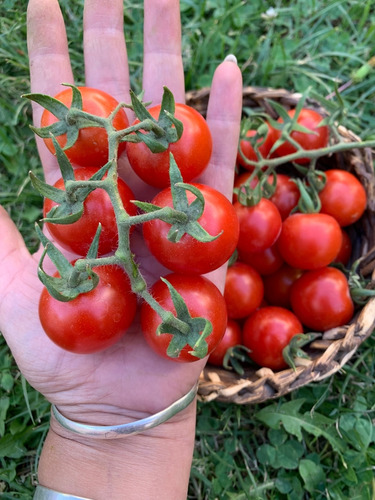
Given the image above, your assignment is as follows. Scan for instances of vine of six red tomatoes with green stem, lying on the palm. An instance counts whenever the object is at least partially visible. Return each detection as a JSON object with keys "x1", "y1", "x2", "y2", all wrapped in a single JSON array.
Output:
[{"x1": 26, "y1": 86, "x2": 239, "y2": 362}]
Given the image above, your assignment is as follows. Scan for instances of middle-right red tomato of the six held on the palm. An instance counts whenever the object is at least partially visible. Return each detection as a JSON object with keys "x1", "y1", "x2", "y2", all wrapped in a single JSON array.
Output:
[{"x1": 143, "y1": 184, "x2": 239, "y2": 274}]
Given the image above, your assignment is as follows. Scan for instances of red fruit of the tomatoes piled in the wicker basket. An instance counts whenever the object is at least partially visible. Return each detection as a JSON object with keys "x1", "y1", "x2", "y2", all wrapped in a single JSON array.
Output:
[{"x1": 209, "y1": 109, "x2": 367, "y2": 376}]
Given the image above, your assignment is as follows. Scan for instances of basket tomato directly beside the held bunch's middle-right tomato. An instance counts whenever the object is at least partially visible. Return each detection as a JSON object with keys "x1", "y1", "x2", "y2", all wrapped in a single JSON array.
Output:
[{"x1": 234, "y1": 198, "x2": 282, "y2": 253}]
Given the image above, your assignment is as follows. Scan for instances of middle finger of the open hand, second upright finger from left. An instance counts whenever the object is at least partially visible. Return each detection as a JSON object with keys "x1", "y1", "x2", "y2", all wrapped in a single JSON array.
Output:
[{"x1": 83, "y1": 0, "x2": 130, "y2": 102}]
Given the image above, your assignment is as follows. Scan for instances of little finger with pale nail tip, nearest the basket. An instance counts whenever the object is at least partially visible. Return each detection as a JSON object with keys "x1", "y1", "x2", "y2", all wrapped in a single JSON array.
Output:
[{"x1": 199, "y1": 56, "x2": 242, "y2": 200}]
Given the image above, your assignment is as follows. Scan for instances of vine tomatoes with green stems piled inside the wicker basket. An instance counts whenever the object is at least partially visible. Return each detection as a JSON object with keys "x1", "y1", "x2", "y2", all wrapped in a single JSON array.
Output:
[{"x1": 209, "y1": 96, "x2": 374, "y2": 374}]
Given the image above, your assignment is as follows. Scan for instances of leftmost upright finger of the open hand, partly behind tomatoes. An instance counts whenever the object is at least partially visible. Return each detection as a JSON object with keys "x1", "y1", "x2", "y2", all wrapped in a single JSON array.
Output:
[{"x1": 27, "y1": 0, "x2": 73, "y2": 185}]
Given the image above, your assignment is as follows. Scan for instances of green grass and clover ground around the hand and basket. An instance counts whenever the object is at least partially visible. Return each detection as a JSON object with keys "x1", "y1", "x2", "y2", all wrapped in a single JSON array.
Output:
[{"x1": 0, "y1": 0, "x2": 375, "y2": 500}]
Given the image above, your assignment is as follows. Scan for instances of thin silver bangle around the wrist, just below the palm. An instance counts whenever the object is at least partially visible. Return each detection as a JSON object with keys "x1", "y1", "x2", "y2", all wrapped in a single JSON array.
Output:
[{"x1": 52, "y1": 383, "x2": 198, "y2": 439}]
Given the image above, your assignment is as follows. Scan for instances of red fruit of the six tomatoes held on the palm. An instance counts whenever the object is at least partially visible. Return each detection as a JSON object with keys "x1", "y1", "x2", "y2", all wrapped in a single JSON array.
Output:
[{"x1": 39, "y1": 87, "x2": 239, "y2": 362}]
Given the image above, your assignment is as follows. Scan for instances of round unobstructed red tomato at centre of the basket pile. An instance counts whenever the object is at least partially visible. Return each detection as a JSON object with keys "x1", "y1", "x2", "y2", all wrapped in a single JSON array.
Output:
[{"x1": 277, "y1": 213, "x2": 342, "y2": 269}]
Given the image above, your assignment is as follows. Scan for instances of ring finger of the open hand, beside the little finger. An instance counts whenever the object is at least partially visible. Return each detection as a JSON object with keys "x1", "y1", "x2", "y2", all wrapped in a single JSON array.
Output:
[{"x1": 143, "y1": 0, "x2": 185, "y2": 104}]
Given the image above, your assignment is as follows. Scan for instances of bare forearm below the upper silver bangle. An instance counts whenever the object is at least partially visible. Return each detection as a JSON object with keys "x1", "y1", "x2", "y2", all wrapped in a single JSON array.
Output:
[{"x1": 38, "y1": 403, "x2": 196, "y2": 500}]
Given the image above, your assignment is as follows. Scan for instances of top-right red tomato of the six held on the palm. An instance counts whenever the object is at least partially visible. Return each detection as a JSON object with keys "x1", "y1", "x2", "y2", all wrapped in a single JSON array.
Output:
[{"x1": 126, "y1": 103, "x2": 212, "y2": 188}]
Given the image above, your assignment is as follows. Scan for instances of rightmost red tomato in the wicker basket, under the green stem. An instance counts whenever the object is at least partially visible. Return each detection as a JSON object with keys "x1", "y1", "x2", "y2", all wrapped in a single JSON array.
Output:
[{"x1": 319, "y1": 169, "x2": 367, "y2": 227}]
